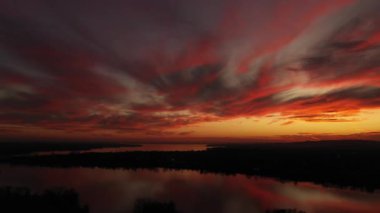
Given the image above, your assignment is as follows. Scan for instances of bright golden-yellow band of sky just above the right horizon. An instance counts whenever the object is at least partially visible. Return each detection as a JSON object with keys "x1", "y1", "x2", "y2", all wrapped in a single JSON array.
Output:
[{"x1": 176, "y1": 109, "x2": 380, "y2": 138}]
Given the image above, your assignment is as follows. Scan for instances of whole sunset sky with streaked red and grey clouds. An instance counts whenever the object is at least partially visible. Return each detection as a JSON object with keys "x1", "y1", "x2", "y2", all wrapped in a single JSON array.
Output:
[{"x1": 0, "y1": 0, "x2": 380, "y2": 142}]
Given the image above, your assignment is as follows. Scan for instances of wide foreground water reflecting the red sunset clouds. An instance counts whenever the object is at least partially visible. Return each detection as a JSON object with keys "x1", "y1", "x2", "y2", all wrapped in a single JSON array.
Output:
[{"x1": 0, "y1": 165, "x2": 380, "y2": 213}]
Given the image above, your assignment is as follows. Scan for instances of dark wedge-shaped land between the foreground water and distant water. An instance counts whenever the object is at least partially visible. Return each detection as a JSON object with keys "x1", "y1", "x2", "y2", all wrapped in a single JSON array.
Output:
[{"x1": 2, "y1": 141, "x2": 380, "y2": 192}]
